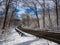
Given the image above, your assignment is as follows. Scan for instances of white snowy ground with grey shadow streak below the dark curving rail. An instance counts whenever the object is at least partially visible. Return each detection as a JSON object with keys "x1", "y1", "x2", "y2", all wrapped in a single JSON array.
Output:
[{"x1": 0, "y1": 28, "x2": 58, "y2": 45}]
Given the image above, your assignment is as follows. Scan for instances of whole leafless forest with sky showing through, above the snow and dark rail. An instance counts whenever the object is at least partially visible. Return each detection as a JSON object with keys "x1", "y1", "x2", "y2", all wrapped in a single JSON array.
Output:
[{"x1": 0, "y1": 0, "x2": 60, "y2": 45}]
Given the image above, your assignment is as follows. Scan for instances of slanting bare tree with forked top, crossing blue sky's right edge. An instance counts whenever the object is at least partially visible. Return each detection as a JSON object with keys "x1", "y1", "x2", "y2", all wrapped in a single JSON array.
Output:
[{"x1": 21, "y1": 0, "x2": 40, "y2": 27}]
